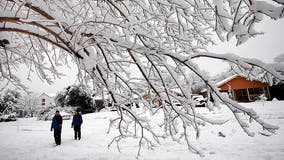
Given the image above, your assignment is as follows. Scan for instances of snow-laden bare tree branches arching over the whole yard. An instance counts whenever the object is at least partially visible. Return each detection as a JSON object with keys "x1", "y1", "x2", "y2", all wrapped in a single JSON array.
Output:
[{"x1": 0, "y1": 0, "x2": 284, "y2": 158}]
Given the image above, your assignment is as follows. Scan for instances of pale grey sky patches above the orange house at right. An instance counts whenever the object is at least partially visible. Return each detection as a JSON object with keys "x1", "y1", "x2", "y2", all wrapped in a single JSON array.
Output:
[{"x1": 198, "y1": 19, "x2": 284, "y2": 75}]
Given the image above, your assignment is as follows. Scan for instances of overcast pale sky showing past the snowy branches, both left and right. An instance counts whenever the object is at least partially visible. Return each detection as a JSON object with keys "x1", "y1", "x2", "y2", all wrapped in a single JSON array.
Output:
[{"x1": 7, "y1": 19, "x2": 284, "y2": 94}]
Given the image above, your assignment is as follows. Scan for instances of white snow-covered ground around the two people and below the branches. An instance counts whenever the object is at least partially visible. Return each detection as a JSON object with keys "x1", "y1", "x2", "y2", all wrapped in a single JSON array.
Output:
[{"x1": 0, "y1": 101, "x2": 284, "y2": 160}]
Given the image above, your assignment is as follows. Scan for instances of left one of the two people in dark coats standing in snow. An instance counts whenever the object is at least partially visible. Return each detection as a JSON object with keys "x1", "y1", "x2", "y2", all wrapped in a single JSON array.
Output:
[{"x1": 50, "y1": 110, "x2": 62, "y2": 145}]
